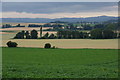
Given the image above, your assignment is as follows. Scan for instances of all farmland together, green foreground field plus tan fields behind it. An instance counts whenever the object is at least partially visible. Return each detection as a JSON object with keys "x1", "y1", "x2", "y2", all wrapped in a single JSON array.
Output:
[{"x1": 0, "y1": 23, "x2": 118, "y2": 78}]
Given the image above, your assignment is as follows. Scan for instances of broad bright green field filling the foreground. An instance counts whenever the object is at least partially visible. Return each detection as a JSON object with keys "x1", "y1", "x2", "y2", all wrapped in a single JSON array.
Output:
[{"x1": 2, "y1": 48, "x2": 118, "y2": 78}]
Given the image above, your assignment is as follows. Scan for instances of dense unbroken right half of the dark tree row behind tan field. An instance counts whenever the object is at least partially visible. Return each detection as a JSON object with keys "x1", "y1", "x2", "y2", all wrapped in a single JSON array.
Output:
[{"x1": 57, "y1": 29, "x2": 120, "y2": 39}]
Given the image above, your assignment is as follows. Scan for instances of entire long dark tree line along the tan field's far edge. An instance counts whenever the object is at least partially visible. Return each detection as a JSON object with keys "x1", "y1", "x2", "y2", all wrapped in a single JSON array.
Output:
[{"x1": 14, "y1": 27, "x2": 120, "y2": 39}]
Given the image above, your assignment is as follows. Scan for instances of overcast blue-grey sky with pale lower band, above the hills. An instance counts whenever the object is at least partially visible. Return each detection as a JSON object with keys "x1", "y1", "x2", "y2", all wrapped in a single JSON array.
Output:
[{"x1": 0, "y1": 2, "x2": 118, "y2": 18}]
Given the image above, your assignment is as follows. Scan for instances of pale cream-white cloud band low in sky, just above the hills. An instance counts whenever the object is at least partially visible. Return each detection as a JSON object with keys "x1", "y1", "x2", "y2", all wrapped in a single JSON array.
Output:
[{"x1": 2, "y1": 11, "x2": 118, "y2": 18}]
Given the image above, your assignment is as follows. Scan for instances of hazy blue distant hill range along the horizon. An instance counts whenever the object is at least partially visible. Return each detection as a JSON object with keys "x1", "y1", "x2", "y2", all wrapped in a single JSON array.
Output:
[{"x1": 0, "y1": 16, "x2": 118, "y2": 23}]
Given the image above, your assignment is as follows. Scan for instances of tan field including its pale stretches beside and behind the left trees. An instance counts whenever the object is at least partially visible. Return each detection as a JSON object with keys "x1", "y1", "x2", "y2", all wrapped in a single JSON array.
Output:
[{"x1": 0, "y1": 28, "x2": 118, "y2": 49}]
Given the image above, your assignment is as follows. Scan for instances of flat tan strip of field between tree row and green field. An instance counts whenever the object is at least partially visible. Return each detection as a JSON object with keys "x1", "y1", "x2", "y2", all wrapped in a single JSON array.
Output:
[{"x1": 2, "y1": 39, "x2": 118, "y2": 49}]
